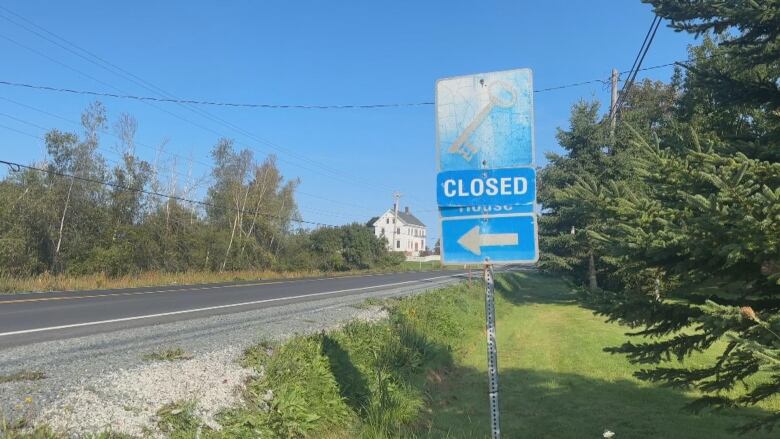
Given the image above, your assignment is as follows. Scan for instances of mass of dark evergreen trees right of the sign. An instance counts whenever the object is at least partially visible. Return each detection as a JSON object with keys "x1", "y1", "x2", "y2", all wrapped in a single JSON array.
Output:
[{"x1": 539, "y1": 0, "x2": 780, "y2": 429}]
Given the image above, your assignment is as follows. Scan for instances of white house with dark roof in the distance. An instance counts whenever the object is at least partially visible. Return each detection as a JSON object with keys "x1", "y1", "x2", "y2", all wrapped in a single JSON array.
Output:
[{"x1": 369, "y1": 206, "x2": 428, "y2": 256}]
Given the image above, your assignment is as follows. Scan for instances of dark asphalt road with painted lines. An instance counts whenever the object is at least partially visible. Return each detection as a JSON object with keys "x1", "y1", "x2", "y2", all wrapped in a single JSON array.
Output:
[{"x1": 0, "y1": 271, "x2": 470, "y2": 349}]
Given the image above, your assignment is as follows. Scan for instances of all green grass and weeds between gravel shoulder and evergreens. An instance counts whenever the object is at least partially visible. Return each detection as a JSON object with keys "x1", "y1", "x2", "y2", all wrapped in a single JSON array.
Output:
[{"x1": 7, "y1": 273, "x2": 780, "y2": 439}]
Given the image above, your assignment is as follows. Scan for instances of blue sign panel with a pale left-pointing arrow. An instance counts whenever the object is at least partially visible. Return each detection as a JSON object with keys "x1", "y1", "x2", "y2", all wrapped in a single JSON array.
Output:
[{"x1": 441, "y1": 214, "x2": 539, "y2": 264}]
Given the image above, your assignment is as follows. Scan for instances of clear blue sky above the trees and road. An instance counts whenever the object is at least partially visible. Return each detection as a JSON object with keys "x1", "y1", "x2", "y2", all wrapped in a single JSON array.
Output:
[{"x1": 0, "y1": 0, "x2": 694, "y2": 245}]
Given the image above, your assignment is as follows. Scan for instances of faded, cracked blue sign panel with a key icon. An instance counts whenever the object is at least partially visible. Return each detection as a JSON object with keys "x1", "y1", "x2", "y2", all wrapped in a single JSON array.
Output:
[{"x1": 436, "y1": 69, "x2": 534, "y2": 171}]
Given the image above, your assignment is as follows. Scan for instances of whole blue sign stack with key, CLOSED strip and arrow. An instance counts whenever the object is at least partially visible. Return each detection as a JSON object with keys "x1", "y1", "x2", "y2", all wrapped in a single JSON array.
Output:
[{"x1": 436, "y1": 69, "x2": 539, "y2": 264}]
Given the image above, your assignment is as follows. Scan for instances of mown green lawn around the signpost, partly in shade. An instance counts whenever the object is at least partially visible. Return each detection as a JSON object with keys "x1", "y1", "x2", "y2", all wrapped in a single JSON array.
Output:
[{"x1": 418, "y1": 274, "x2": 780, "y2": 438}]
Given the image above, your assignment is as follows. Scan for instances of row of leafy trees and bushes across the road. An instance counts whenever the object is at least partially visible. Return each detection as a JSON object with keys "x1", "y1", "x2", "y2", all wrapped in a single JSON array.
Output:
[{"x1": 0, "y1": 102, "x2": 403, "y2": 277}]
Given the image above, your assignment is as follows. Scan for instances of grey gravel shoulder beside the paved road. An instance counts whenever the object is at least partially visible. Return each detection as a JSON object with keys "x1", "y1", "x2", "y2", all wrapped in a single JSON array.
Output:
[{"x1": 0, "y1": 278, "x2": 458, "y2": 436}]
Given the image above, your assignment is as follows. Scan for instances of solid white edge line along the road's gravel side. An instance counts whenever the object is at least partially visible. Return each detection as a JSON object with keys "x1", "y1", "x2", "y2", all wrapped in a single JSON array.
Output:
[{"x1": 0, "y1": 274, "x2": 462, "y2": 337}]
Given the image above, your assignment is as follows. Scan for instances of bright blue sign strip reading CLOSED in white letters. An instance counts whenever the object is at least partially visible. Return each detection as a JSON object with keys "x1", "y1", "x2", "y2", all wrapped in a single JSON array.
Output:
[{"x1": 436, "y1": 168, "x2": 536, "y2": 207}]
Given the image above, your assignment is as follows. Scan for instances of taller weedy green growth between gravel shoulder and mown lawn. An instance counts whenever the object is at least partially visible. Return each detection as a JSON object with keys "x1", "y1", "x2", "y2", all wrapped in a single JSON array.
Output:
[{"x1": 221, "y1": 287, "x2": 468, "y2": 438}]
